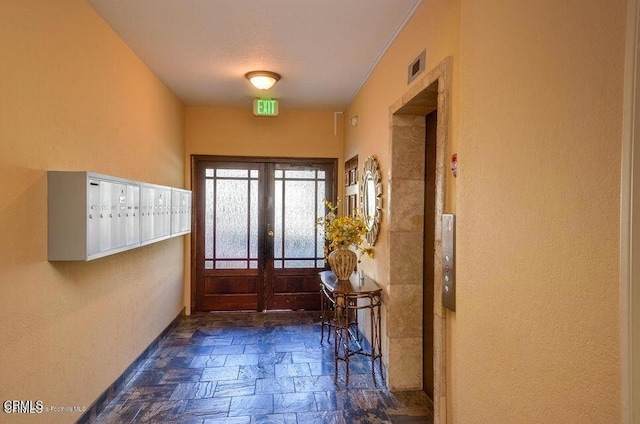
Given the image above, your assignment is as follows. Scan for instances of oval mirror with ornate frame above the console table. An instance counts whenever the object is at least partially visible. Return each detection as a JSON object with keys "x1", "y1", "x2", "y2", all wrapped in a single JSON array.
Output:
[{"x1": 360, "y1": 156, "x2": 382, "y2": 246}]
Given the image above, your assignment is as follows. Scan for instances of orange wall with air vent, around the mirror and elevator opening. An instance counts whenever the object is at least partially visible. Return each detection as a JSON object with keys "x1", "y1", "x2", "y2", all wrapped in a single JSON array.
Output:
[{"x1": 344, "y1": 0, "x2": 460, "y2": 288}]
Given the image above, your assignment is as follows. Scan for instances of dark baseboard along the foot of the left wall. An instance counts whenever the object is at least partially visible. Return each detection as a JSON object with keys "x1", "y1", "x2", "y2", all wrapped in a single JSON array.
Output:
[{"x1": 76, "y1": 308, "x2": 185, "y2": 424}]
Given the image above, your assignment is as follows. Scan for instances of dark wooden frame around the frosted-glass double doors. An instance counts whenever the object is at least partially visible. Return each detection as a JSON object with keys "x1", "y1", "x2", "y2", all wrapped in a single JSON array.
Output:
[{"x1": 190, "y1": 154, "x2": 338, "y2": 314}]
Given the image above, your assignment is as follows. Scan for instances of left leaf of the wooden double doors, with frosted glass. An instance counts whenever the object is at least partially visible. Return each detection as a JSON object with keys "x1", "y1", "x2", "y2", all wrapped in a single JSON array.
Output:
[{"x1": 196, "y1": 162, "x2": 264, "y2": 311}]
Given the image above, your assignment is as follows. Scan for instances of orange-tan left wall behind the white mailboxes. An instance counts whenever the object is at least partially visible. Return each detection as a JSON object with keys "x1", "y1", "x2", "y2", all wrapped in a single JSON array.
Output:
[{"x1": 0, "y1": 0, "x2": 184, "y2": 423}]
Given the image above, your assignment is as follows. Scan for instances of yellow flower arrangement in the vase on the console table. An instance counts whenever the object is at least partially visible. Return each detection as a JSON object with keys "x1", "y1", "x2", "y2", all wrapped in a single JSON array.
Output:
[{"x1": 317, "y1": 199, "x2": 373, "y2": 262}]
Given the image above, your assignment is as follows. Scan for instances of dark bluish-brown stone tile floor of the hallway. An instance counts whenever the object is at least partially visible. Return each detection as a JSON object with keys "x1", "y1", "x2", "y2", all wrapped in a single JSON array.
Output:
[{"x1": 95, "y1": 312, "x2": 433, "y2": 424}]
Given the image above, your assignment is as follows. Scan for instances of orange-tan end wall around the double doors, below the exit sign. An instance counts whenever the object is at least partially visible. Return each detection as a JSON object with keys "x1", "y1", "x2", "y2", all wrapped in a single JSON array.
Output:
[{"x1": 185, "y1": 107, "x2": 344, "y2": 310}]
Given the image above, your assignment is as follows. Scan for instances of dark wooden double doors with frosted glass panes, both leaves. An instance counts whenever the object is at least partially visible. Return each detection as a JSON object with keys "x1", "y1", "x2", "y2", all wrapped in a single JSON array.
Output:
[{"x1": 192, "y1": 156, "x2": 337, "y2": 312}]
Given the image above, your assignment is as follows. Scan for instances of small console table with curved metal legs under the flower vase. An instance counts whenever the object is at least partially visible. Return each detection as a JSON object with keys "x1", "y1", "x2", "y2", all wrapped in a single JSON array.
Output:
[{"x1": 320, "y1": 271, "x2": 384, "y2": 386}]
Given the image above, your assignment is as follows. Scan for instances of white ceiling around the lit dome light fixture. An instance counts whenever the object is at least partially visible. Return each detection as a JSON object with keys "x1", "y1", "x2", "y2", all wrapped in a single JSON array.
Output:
[{"x1": 87, "y1": 0, "x2": 422, "y2": 111}]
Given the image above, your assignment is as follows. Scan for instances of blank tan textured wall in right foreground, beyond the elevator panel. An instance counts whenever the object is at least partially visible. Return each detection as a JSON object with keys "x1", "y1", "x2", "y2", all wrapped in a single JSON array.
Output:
[{"x1": 454, "y1": 0, "x2": 626, "y2": 424}]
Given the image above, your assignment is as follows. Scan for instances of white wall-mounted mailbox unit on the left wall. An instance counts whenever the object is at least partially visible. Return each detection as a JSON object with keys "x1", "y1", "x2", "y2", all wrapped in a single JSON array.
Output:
[{"x1": 47, "y1": 171, "x2": 191, "y2": 261}]
